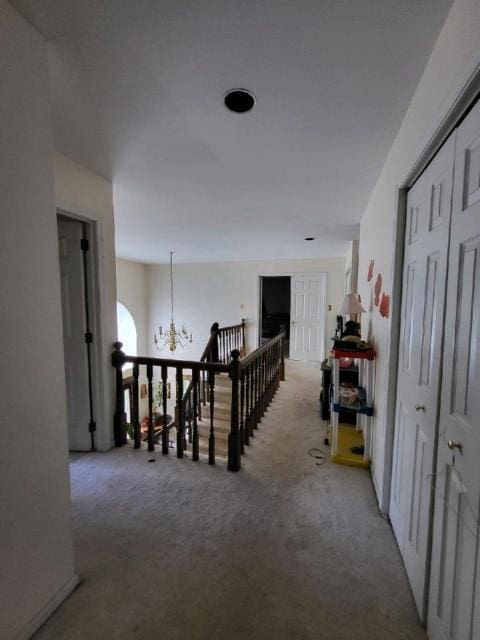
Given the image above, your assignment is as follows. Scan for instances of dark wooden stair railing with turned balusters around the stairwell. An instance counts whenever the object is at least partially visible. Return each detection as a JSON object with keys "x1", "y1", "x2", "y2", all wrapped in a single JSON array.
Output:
[{"x1": 112, "y1": 320, "x2": 285, "y2": 471}]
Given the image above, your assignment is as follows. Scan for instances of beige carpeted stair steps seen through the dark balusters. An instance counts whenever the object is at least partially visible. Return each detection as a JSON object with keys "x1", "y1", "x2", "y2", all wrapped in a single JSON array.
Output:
[{"x1": 198, "y1": 373, "x2": 232, "y2": 460}]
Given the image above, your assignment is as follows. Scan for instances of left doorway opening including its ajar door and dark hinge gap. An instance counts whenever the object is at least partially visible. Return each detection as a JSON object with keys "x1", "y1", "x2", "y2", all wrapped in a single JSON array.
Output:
[{"x1": 57, "y1": 212, "x2": 96, "y2": 451}]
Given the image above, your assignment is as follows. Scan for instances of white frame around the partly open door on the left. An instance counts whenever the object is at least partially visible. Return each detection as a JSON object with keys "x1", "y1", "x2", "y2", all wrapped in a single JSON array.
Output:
[{"x1": 57, "y1": 207, "x2": 105, "y2": 451}]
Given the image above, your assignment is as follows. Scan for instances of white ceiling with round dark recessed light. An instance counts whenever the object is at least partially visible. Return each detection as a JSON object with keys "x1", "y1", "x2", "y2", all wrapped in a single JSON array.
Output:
[{"x1": 12, "y1": 0, "x2": 451, "y2": 263}]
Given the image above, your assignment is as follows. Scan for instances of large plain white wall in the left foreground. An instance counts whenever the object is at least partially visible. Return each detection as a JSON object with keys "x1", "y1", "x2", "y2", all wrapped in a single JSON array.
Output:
[{"x1": 0, "y1": 0, "x2": 76, "y2": 640}]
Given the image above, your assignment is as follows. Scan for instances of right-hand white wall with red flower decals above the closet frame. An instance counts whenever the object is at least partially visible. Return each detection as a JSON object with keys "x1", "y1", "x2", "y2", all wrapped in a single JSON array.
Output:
[{"x1": 359, "y1": 0, "x2": 480, "y2": 509}]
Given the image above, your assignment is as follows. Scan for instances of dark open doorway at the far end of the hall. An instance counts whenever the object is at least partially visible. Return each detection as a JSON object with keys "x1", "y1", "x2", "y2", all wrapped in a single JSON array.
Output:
[{"x1": 260, "y1": 276, "x2": 290, "y2": 357}]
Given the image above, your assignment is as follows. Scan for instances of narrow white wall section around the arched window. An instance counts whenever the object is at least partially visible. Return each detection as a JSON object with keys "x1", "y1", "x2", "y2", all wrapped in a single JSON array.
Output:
[{"x1": 117, "y1": 259, "x2": 148, "y2": 356}]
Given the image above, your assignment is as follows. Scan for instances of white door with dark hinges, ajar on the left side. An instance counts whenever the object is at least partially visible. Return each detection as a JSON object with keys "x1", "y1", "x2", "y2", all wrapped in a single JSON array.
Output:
[{"x1": 58, "y1": 217, "x2": 92, "y2": 451}]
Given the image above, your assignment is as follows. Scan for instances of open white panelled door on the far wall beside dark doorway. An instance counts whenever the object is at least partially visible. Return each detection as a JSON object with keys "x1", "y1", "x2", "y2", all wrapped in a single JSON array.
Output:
[{"x1": 290, "y1": 273, "x2": 327, "y2": 360}]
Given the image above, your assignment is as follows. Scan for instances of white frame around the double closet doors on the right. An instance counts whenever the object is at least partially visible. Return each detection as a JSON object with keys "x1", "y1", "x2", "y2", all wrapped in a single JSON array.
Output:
[{"x1": 379, "y1": 51, "x2": 480, "y2": 514}]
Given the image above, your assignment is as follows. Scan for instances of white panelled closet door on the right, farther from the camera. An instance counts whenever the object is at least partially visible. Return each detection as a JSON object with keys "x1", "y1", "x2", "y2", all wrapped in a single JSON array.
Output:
[{"x1": 390, "y1": 134, "x2": 455, "y2": 620}]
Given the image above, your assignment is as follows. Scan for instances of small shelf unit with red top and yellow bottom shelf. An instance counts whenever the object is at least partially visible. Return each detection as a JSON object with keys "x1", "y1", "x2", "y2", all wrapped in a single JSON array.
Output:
[{"x1": 331, "y1": 348, "x2": 375, "y2": 467}]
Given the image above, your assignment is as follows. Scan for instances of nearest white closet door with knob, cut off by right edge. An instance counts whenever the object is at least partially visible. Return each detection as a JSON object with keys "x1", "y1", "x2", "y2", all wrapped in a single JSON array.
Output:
[{"x1": 428, "y1": 97, "x2": 480, "y2": 640}]
